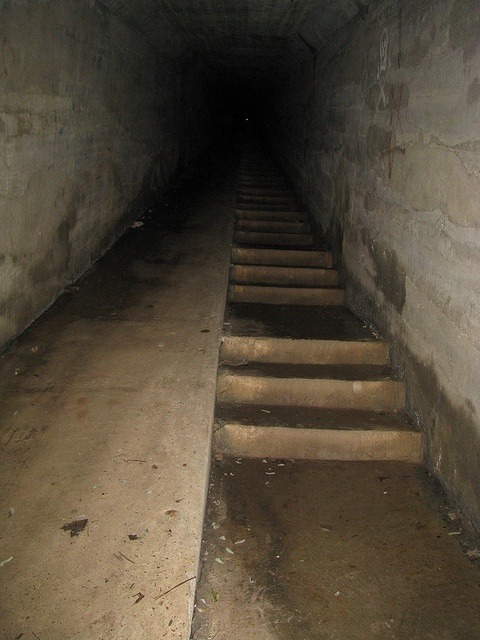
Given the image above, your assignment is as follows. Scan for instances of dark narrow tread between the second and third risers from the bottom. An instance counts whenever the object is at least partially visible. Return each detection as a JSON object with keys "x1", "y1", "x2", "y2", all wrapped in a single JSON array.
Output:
[{"x1": 219, "y1": 361, "x2": 399, "y2": 381}]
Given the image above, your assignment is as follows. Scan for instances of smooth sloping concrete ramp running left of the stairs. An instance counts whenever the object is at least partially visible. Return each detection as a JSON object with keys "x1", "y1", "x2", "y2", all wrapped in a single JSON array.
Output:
[{"x1": 0, "y1": 154, "x2": 233, "y2": 640}]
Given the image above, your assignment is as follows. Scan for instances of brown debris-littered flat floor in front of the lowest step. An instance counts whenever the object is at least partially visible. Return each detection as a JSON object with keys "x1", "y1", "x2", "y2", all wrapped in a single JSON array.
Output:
[{"x1": 194, "y1": 459, "x2": 480, "y2": 640}]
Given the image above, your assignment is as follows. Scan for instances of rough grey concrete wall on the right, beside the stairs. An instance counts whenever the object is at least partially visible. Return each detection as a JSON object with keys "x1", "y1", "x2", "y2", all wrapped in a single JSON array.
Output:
[{"x1": 271, "y1": 0, "x2": 480, "y2": 524}]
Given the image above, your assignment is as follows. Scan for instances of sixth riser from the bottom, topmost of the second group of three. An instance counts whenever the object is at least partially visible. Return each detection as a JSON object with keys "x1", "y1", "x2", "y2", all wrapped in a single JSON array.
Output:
[{"x1": 232, "y1": 247, "x2": 333, "y2": 268}]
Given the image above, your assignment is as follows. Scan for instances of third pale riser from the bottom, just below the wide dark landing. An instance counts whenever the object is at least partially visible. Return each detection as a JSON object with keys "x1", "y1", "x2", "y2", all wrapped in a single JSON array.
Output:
[{"x1": 220, "y1": 336, "x2": 390, "y2": 366}]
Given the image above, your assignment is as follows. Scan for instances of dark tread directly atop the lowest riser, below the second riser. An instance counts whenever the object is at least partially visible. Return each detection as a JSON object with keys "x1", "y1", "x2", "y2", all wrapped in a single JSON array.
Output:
[{"x1": 215, "y1": 402, "x2": 417, "y2": 432}]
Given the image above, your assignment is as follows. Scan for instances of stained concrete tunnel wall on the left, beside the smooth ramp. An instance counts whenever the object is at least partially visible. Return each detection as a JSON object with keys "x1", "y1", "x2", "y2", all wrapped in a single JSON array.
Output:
[{"x1": 0, "y1": 0, "x2": 214, "y2": 350}]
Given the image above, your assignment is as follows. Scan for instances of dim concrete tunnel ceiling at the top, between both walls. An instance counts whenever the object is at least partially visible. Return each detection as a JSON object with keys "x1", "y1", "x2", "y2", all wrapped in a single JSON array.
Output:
[{"x1": 103, "y1": 0, "x2": 367, "y2": 69}]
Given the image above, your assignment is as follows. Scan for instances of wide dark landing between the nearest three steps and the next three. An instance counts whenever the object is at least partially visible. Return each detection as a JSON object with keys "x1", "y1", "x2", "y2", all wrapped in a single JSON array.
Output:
[{"x1": 224, "y1": 302, "x2": 379, "y2": 340}]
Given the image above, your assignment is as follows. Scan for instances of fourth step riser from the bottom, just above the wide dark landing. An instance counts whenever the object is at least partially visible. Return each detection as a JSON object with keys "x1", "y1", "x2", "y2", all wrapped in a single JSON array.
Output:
[{"x1": 228, "y1": 284, "x2": 344, "y2": 306}]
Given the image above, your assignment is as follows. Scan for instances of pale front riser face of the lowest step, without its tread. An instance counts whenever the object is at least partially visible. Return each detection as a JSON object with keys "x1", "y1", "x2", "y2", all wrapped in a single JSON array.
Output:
[{"x1": 213, "y1": 425, "x2": 422, "y2": 464}]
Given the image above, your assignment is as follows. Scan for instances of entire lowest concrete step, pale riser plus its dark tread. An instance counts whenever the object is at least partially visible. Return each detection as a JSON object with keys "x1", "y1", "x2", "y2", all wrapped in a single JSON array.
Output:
[{"x1": 213, "y1": 403, "x2": 422, "y2": 463}]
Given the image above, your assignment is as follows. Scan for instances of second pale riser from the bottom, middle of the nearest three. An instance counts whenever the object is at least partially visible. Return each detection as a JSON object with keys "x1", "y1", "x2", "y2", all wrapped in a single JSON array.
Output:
[{"x1": 217, "y1": 373, "x2": 405, "y2": 411}]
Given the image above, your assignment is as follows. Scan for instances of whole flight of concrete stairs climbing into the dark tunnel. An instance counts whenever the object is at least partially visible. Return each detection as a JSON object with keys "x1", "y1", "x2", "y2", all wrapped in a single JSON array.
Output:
[{"x1": 214, "y1": 152, "x2": 422, "y2": 462}]
